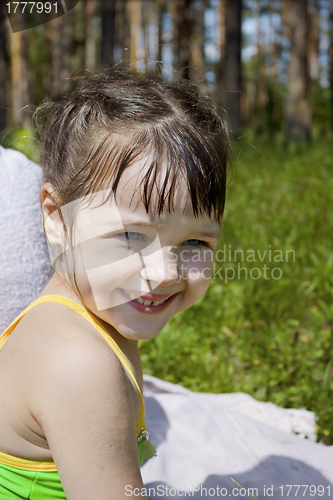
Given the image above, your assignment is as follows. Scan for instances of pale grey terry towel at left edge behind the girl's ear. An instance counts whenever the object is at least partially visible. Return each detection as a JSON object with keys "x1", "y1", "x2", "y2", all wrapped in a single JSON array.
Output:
[{"x1": 0, "y1": 146, "x2": 49, "y2": 332}]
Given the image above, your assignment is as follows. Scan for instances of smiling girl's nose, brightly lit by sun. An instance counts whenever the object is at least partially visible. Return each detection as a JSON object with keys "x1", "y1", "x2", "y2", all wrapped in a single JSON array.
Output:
[{"x1": 141, "y1": 246, "x2": 181, "y2": 288}]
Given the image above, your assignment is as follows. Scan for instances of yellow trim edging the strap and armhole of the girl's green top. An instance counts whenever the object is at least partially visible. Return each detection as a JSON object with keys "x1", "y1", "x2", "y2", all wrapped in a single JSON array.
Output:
[{"x1": 0, "y1": 295, "x2": 146, "y2": 471}]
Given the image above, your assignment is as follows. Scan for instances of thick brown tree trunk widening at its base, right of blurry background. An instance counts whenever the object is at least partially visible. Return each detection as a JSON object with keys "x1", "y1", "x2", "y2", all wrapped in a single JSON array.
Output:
[{"x1": 284, "y1": 0, "x2": 311, "y2": 140}]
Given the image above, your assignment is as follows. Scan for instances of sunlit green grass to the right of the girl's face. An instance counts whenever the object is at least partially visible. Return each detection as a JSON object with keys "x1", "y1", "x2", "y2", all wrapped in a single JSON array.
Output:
[{"x1": 141, "y1": 136, "x2": 333, "y2": 444}]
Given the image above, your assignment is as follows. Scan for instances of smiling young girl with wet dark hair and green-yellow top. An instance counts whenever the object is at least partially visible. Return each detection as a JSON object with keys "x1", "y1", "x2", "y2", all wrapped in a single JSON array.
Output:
[{"x1": 0, "y1": 72, "x2": 228, "y2": 500}]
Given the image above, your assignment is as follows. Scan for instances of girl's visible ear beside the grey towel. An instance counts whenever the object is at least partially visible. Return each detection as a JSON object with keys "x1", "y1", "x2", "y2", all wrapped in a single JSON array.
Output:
[{"x1": 40, "y1": 182, "x2": 64, "y2": 248}]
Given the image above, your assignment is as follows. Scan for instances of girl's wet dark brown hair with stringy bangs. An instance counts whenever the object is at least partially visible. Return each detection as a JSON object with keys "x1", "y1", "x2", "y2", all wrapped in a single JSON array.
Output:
[{"x1": 36, "y1": 70, "x2": 229, "y2": 292}]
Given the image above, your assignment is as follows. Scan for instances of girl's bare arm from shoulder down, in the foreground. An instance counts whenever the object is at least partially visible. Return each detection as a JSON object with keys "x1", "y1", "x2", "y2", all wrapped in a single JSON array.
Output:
[{"x1": 30, "y1": 320, "x2": 146, "y2": 500}]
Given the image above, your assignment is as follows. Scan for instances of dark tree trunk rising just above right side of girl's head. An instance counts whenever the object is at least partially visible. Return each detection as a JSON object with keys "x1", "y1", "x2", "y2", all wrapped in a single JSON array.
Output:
[{"x1": 218, "y1": 0, "x2": 242, "y2": 132}]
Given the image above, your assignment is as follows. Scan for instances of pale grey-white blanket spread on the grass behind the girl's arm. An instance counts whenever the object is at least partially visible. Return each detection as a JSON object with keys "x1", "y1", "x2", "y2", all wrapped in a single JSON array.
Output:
[{"x1": 141, "y1": 375, "x2": 333, "y2": 500}]
